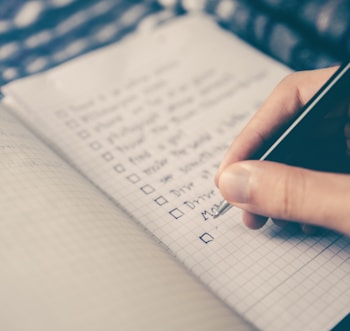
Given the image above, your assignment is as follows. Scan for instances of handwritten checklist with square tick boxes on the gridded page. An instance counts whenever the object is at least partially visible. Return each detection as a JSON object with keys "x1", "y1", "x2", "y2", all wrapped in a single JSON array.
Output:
[{"x1": 50, "y1": 60, "x2": 267, "y2": 243}]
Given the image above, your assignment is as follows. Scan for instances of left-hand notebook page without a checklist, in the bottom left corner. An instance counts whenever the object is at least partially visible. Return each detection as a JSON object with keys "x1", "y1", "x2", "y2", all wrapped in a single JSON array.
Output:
[{"x1": 0, "y1": 106, "x2": 252, "y2": 331}]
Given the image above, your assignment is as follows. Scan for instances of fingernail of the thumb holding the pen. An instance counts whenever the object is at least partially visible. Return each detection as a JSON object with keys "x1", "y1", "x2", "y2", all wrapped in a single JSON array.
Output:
[{"x1": 219, "y1": 165, "x2": 250, "y2": 203}]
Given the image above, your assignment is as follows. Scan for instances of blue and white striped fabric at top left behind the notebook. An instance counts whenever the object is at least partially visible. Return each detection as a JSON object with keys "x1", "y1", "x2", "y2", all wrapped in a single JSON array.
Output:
[{"x1": 0, "y1": 0, "x2": 175, "y2": 86}]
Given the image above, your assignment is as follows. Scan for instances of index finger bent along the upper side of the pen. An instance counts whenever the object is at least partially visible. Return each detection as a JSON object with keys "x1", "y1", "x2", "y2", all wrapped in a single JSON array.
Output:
[{"x1": 215, "y1": 67, "x2": 338, "y2": 185}]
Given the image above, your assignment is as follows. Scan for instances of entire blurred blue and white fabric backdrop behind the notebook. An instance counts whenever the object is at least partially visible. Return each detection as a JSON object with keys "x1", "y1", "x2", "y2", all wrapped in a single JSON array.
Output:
[{"x1": 0, "y1": 0, "x2": 350, "y2": 86}]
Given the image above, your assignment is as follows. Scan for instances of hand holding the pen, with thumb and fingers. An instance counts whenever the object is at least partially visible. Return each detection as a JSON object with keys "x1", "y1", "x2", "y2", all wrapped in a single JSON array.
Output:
[{"x1": 215, "y1": 67, "x2": 350, "y2": 235}]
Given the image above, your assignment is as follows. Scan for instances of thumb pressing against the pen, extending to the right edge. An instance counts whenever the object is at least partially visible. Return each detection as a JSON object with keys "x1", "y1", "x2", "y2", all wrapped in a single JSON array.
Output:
[{"x1": 219, "y1": 161, "x2": 350, "y2": 235}]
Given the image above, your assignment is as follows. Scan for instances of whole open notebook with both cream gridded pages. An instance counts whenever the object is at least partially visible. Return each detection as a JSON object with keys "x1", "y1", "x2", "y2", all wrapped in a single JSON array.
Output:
[{"x1": 0, "y1": 16, "x2": 350, "y2": 331}]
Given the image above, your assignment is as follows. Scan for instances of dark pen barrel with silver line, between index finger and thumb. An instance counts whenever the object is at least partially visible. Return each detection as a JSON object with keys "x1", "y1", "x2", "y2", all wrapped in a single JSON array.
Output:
[{"x1": 252, "y1": 62, "x2": 350, "y2": 172}]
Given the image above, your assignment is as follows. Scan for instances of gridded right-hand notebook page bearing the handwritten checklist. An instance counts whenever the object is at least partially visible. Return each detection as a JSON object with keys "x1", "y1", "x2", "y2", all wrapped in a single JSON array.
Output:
[{"x1": 5, "y1": 17, "x2": 350, "y2": 330}]
